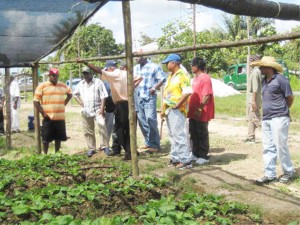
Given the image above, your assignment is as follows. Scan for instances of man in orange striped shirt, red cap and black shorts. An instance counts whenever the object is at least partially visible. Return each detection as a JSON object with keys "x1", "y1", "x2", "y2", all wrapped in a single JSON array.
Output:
[{"x1": 33, "y1": 68, "x2": 72, "y2": 154}]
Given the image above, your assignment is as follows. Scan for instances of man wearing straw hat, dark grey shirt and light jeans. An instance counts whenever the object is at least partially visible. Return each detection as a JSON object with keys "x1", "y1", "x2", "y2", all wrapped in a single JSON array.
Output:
[{"x1": 251, "y1": 56, "x2": 294, "y2": 184}]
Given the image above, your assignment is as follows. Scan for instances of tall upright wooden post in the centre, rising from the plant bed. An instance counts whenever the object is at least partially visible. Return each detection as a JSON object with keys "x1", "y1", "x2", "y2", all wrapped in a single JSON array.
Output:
[{"x1": 122, "y1": 1, "x2": 139, "y2": 177}]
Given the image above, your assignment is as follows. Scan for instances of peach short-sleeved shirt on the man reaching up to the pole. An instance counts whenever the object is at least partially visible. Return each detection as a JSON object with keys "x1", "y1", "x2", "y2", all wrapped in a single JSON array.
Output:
[{"x1": 101, "y1": 69, "x2": 128, "y2": 104}]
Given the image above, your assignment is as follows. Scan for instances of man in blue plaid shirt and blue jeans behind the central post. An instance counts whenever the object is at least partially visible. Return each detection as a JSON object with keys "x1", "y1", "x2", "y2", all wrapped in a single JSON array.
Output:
[{"x1": 133, "y1": 57, "x2": 166, "y2": 152}]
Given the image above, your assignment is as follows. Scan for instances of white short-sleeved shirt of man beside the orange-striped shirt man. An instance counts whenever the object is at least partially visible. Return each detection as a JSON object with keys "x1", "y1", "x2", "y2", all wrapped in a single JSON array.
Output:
[{"x1": 73, "y1": 78, "x2": 108, "y2": 117}]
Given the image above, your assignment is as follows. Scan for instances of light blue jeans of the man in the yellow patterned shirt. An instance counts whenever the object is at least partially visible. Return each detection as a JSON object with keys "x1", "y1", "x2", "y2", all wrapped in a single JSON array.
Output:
[{"x1": 167, "y1": 109, "x2": 190, "y2": 163}]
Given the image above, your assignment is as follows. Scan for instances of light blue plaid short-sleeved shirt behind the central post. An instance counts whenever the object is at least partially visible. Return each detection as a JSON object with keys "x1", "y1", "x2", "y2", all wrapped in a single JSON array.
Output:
[{"x1": 133, "y1": 61, "x2": 166, "y2": 99}]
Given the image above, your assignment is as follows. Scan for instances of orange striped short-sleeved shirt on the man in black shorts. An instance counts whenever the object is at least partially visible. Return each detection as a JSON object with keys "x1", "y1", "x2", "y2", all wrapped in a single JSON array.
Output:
[{"x1": 33, "y1": 81, "x2": 72, "y2": 120}]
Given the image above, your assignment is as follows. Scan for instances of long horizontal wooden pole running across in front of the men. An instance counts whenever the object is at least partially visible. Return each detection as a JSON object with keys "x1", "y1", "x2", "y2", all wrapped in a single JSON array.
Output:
[{"x1": 39, "y1": 32, "x2": 300, "y2": 64}]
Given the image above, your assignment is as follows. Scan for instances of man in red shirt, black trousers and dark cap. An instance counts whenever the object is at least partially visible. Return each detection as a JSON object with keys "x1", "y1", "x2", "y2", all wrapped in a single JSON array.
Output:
[{"x1": 187, "y1": 57, "x2": 215, "y2": 164}]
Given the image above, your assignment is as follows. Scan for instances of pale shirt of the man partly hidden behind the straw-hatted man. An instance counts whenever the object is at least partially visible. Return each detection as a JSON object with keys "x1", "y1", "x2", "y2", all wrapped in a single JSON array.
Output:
[{"x1": 247, "y1": 67, "x2": 262, "y2": 108}]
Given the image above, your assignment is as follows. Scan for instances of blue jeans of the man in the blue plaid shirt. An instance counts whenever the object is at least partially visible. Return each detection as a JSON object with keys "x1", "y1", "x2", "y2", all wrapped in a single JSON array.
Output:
[{"x1": 137, "y1": 95, "x2": 160, "y2": 148}]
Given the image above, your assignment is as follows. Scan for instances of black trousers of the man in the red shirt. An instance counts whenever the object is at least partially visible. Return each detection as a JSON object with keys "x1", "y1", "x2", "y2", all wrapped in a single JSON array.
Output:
[{"x1": 189, "y1": 119, "x2": 209, "y2": 159}]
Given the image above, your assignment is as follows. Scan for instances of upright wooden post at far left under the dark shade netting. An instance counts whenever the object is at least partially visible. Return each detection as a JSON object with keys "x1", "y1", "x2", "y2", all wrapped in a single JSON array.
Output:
[{"x1": 4, "y1": 68, "x2": 12, "y2": 149}]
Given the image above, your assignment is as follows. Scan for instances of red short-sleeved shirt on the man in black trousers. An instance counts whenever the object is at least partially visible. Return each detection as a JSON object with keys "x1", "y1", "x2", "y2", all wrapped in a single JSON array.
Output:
[{"x1": 187, "y1": 73, "x2": 215, "y2": 122}]
